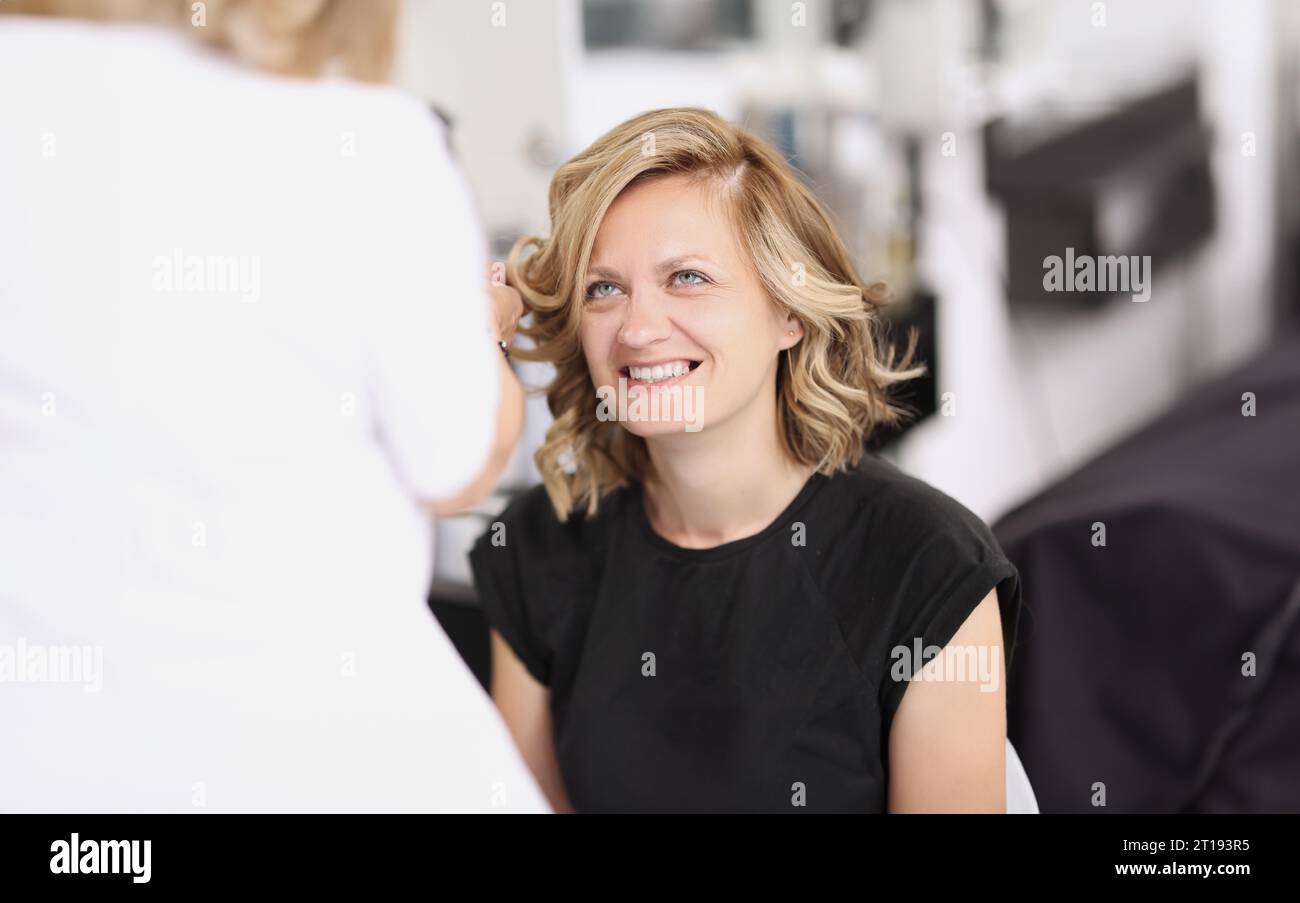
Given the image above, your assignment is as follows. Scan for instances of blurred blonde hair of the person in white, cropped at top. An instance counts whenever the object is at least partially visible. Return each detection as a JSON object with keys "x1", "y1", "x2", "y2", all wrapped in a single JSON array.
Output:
[{"x1": 0, "y1": 0, "x2": 398, "y2": 82}]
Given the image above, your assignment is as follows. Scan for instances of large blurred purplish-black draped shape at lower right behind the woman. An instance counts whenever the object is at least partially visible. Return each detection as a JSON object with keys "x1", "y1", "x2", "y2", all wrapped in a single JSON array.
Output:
[{"x1": 995, "y1": 328, "x2": 1300, "y2": 812}]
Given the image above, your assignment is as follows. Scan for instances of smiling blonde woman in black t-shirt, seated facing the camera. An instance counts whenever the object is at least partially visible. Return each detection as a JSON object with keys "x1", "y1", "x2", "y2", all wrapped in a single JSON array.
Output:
[{"x1": 471, "y1": 109, "x2": 1021, "y2": 812}]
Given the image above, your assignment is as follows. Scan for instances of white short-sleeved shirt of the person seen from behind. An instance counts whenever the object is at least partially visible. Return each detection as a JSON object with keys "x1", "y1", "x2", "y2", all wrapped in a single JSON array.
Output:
[{"x1": 0, "y1": 16, "x2": 547, "y2": 812}]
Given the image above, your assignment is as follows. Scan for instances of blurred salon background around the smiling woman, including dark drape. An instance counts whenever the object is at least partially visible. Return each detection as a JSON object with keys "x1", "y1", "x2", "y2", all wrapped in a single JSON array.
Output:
[{"x1": 413, "y1": 0, "x2": 1300, "y2": 811}]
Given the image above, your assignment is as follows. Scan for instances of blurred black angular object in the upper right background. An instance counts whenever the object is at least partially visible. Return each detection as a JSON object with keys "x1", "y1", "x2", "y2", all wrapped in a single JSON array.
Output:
[{"x1": 984, "y1": 75, "x2": 1214, "y2": 307}]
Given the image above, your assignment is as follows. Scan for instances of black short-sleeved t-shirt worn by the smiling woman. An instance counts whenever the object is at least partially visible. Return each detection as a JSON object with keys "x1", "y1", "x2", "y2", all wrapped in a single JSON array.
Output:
[{"x1": 471, "y1": 455, "x2": 1021, "y2": 812}]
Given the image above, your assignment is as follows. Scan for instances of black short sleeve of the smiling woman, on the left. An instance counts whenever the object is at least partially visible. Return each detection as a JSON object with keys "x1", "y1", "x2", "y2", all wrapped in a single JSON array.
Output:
[{"x1": 469, "y1": 521, "x2": 554, "y2": 686}]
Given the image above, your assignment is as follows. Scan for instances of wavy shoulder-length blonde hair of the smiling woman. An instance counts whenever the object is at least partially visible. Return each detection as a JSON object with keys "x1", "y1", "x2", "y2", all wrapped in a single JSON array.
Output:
[{"x1": 508, "y1": 109, "x2": 926, "y2": 521}]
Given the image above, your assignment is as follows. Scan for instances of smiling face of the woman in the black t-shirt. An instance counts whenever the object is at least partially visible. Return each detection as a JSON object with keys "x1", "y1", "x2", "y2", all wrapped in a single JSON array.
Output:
[{"x1": 581, "y1": 175, "x2": 802, "y2": 437}]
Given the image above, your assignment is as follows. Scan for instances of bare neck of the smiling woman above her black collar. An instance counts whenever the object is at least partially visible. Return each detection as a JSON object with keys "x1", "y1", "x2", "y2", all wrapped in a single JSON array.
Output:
[{"x1": 645, "y1": 397, "x2": 813, "y2": 548}]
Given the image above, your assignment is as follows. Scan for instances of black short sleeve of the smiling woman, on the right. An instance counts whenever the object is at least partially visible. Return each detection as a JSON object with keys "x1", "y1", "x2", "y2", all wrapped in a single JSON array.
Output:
[{"x1": 879, "y1": 492, "x2": 1022, "y2": 722}]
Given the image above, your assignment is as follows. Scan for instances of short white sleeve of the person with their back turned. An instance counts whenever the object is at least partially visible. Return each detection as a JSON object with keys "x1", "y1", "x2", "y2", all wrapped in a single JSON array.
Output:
[{"x1": 367, "y1": 105, "x2": 501, "y2": 500}]
